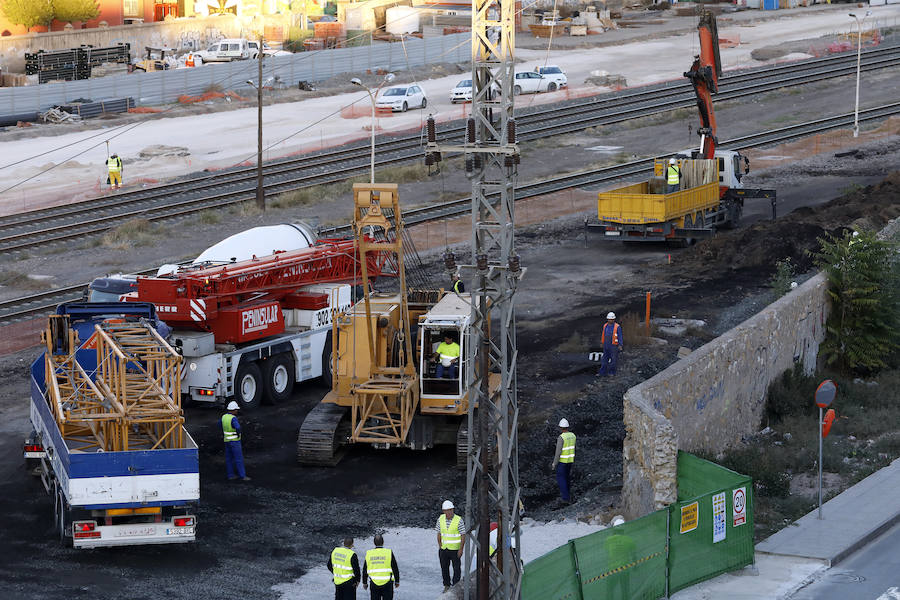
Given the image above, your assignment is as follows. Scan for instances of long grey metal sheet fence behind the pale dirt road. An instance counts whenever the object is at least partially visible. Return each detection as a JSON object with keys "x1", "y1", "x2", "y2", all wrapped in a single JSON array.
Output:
[{"x1": 0, "y1": 33, "x2": 471, "y2": 115}]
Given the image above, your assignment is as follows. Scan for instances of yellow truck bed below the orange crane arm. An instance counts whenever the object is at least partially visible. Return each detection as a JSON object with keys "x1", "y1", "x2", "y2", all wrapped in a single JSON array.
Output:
[{"x1": 597, "y1": 181, "x2": 719, "y2": 224}]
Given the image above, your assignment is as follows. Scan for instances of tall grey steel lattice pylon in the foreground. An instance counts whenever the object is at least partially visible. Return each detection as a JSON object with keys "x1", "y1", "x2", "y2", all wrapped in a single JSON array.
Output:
[{"x1": 425, "y1": 0, "x2": 524, "y2": 600}]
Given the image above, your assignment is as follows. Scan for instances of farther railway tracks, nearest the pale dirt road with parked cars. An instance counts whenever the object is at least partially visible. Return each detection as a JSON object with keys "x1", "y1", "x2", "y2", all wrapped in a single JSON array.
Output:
[{"x1": 0, "y1": 46, "x2": 900, "y2": 253}]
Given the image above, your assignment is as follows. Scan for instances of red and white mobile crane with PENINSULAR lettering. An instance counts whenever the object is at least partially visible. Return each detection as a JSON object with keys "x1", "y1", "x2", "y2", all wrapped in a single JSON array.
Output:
[{"x1": 125, "y1": 234, "x2": 388, "y2": 409}]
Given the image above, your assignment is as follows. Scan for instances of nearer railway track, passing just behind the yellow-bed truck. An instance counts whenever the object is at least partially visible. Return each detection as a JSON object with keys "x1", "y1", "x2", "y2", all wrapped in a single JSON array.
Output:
[{"x1": 0, "y1": 102, "x2": 900, "y2": 324}]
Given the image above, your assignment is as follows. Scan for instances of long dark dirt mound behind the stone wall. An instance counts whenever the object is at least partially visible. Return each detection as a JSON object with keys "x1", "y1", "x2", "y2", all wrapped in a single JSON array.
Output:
[{"x1": 674, "y1": 172, "x2": 900, "y2": 279}]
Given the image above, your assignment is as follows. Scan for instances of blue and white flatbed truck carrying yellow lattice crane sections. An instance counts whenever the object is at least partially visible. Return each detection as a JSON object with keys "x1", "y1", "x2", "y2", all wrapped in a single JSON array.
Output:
[{"x1": 24, "y1": 302, "x2": 200, "y2": 548}]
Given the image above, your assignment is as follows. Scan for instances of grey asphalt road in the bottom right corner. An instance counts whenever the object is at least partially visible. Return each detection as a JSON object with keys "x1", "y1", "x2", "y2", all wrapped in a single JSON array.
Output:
[{"x1": 790, "y1": 523, "x2": 900, "y2": 600}]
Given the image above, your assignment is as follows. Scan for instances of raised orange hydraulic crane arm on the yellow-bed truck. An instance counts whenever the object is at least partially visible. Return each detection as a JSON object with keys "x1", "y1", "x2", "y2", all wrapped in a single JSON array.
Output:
[{"x1": 684, "y1": 11, "x2": 722, "y2": 158}]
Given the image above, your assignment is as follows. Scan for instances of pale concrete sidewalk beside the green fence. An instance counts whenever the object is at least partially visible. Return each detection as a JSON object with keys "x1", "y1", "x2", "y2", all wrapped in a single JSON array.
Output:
[{"x1": 672, "y1": 459, "x2": 900, "y2": 600}]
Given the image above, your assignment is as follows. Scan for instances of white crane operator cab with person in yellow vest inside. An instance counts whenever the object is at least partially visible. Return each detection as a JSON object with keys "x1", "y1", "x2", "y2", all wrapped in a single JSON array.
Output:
[{"x1": 418, "y1": 294, "x2": 472, "y2": 412}]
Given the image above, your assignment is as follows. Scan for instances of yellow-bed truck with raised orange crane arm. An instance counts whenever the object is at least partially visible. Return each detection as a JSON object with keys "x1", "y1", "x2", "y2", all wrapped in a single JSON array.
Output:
[{"x1": 588, "y1": 11, "x2": 776, "y2": 244}]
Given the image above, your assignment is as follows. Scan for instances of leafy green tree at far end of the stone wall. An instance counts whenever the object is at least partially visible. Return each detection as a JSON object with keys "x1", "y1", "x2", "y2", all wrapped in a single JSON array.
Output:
[{"x1": 814, "y1": 232, "x2": 900, "y2": 374}]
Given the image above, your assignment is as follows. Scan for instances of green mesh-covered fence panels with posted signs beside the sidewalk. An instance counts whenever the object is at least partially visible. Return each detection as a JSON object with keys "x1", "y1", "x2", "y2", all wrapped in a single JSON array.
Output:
[{"x1": 522, "y1": 452, "x2": 753, "y2": 600}]
